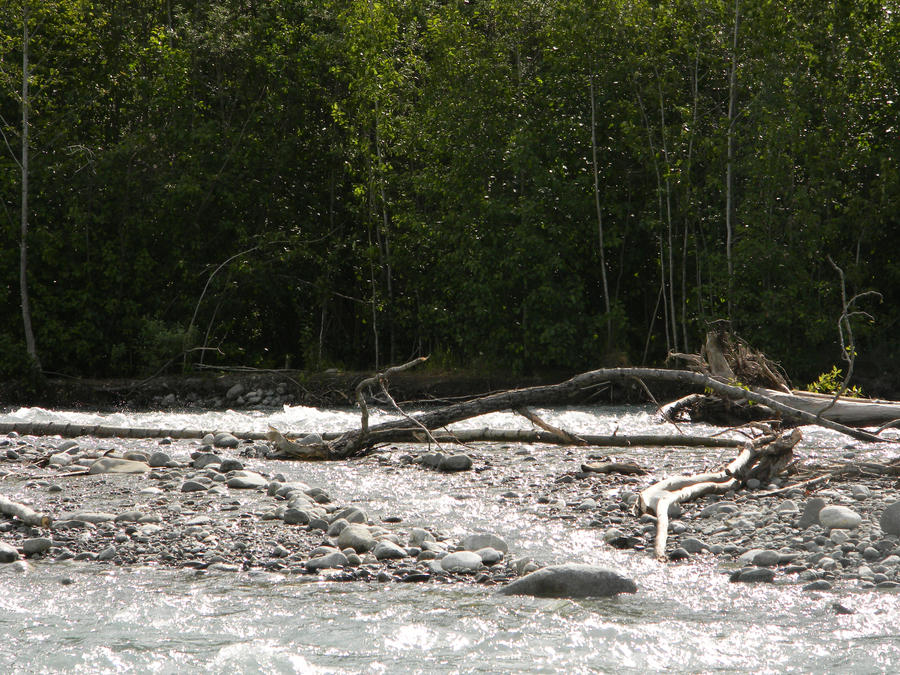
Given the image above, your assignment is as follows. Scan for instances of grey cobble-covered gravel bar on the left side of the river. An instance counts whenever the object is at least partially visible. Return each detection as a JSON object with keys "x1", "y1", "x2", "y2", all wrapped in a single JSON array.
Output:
[{"x1": 0, "y1": 434, "x2": 537, "y2": 585}]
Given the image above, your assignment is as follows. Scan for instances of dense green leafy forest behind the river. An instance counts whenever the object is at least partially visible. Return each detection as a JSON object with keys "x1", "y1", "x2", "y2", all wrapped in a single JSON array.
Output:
[{"x1": 0, "y1": 0, "x2": 900, "y2": 388}]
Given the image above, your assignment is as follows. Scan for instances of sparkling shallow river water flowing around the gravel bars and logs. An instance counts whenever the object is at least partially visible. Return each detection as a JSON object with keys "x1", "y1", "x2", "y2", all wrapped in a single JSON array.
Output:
[{"x1": 0, "y1": 407, "x2": 900, "y2": 673}]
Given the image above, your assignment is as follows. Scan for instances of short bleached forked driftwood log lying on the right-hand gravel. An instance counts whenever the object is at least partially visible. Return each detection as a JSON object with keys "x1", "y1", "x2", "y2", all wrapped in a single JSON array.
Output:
[{"x1": 636, "y1": 429, "x2": 802, "y2": 560}]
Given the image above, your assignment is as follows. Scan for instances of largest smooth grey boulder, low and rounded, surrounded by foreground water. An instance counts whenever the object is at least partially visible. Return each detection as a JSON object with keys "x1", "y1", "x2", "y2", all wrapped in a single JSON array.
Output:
[{"x1": 499, "y1": 563, "x2": 637, "y2": 598}]
